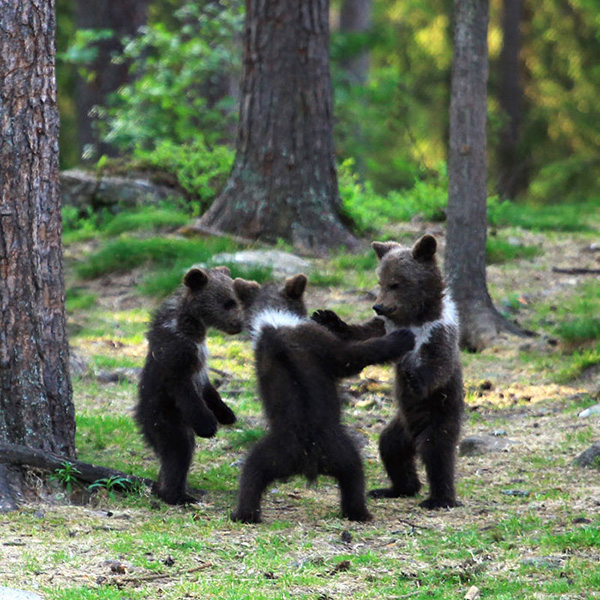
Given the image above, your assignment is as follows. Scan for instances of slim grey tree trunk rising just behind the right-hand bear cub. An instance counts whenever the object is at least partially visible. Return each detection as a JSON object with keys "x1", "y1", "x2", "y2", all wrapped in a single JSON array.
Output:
[{"x1": 445, "y1": 0, "x2": 518, "y2": 350}]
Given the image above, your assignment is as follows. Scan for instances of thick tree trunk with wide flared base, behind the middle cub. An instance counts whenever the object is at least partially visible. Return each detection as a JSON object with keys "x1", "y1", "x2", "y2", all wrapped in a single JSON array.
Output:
[{"x1": 198, "y1": 0, "x2": 356, "y2": 250}]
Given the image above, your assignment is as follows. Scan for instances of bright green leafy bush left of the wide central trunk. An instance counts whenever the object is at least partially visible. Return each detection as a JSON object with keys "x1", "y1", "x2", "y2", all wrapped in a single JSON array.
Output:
[{"x1": 102, "y1": 0, "x2": 243, "y2": 156}]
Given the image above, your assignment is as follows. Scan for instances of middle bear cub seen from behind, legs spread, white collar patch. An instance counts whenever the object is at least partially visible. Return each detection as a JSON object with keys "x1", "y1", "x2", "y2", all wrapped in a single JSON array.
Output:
[{"x1": 227, "y1": 275, "x2": 414, "y2": 523}]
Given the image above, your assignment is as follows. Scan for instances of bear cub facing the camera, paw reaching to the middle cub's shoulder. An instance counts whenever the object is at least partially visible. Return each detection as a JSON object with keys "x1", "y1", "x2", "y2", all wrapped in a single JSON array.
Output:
[{"x1": 313, "y1": 235, "x2": 463, "y2": 508}]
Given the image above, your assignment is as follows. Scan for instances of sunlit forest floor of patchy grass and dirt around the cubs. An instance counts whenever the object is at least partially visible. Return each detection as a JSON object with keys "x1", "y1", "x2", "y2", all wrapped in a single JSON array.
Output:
[{"x1": 0, "y1": 216, "x2": 600, "y2": 600}]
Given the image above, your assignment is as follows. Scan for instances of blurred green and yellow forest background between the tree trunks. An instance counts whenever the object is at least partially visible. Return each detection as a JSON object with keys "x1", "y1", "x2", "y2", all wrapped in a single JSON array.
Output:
[{"x1": 57, "y1": 0, "x2": 600, "y2": 210}]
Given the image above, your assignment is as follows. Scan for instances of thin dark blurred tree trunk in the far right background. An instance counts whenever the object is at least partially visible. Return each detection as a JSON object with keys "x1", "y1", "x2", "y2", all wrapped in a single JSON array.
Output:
[{"x1": 498, "y1": 0, "x2": 527, "y2": 199}]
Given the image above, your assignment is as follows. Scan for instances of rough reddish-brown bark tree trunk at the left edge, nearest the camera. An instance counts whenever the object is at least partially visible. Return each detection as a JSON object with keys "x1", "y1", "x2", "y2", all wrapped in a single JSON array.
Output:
[{"x1": 0, "y1": 0, "x2": 75, "y2": 510}]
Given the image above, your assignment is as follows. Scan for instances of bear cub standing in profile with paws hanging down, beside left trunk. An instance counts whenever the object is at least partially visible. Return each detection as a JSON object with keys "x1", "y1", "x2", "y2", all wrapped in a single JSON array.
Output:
[{"x1": 136, "y1": 267, "x2": 243, "y2": 504}]
